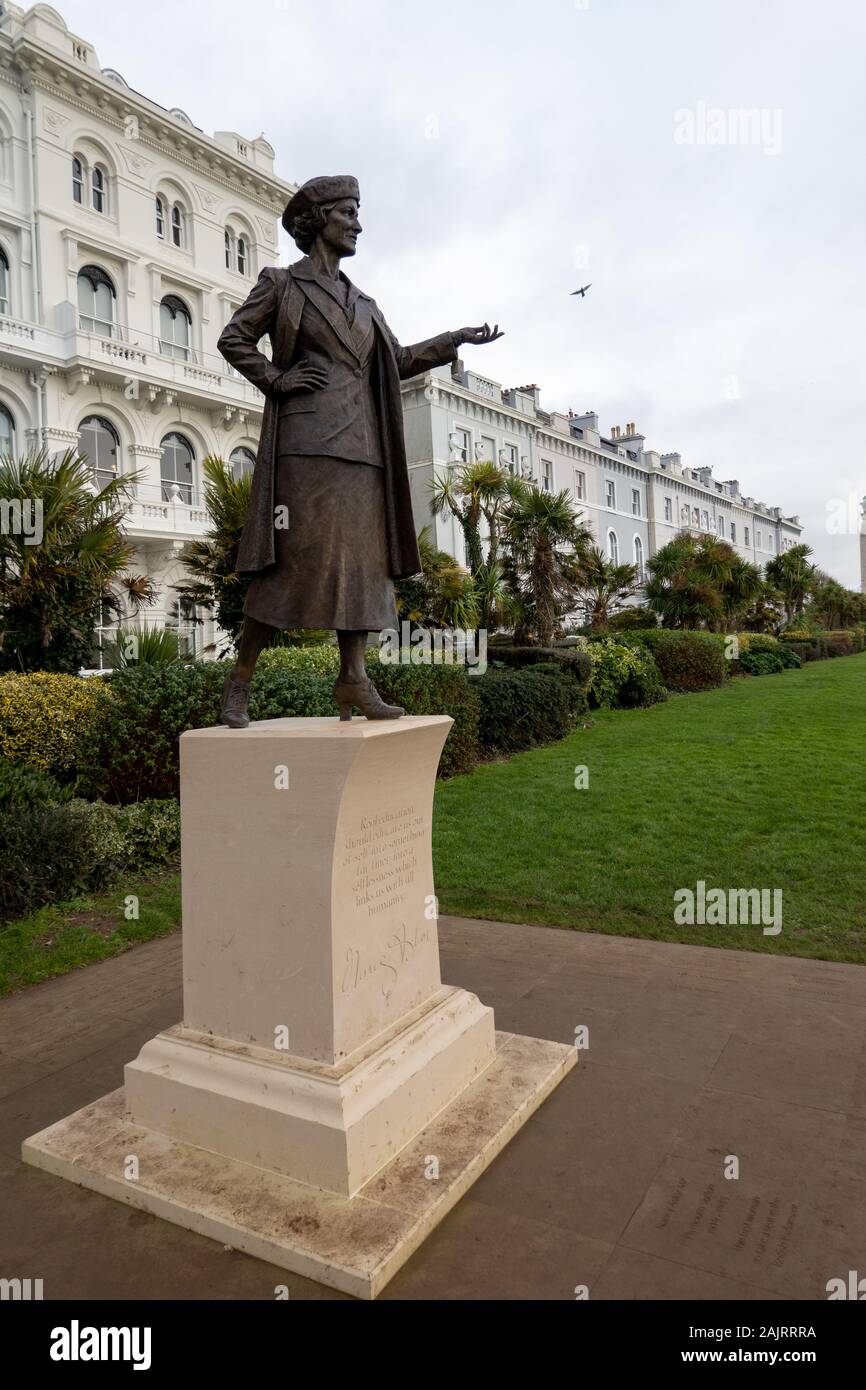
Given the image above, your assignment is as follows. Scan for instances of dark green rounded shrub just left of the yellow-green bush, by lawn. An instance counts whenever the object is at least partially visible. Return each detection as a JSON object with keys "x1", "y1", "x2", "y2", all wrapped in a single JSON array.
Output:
[{"x1": 475, "y1": 662, "x2": 585, "y2": 753}]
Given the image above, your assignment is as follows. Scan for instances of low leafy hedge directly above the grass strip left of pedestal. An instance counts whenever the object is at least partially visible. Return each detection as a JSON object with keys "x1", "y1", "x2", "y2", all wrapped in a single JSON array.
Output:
[{"x1": 0, "y1": 801, "x2": 181, "y2": 920}]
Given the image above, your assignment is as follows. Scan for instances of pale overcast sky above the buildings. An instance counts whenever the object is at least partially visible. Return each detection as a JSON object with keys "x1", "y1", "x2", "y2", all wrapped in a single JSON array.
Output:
[{"x1": 58, "y1": 0, "x2": 866, "y2": 588}]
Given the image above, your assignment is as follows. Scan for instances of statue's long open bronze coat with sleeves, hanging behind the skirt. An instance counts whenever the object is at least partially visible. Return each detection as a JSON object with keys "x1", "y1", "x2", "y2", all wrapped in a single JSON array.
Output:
[{"x1": 218, "y1": 256, "x2": 457, "y2": 580}]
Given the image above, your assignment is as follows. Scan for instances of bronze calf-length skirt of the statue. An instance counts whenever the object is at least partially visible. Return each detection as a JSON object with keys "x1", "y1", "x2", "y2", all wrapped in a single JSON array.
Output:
[{"x1": 243, "y1": 455, "x2": 398, "y2": 632}]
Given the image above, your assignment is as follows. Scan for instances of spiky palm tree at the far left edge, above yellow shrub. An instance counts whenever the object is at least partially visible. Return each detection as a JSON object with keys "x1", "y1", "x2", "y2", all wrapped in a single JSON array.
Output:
[{"x1": 0, "y1": 449, "x2": 138, "y2": 673}]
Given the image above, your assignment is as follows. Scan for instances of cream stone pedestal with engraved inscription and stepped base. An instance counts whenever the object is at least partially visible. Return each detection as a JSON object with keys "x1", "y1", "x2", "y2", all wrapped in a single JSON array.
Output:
[{"x1": 24, "y1": 716, "x2": 577, "y2": 1297}]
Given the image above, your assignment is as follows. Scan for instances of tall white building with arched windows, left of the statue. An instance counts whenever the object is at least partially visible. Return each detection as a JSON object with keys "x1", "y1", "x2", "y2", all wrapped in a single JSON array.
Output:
[{"x1": 0, "y1": 4, "x2": 295, "y2": 651}]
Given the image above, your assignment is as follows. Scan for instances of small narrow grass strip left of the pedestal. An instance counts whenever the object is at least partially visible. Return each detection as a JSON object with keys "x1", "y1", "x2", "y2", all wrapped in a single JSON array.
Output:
[{"x1": 0, "y1": 866, "x2": 181, "y2": 994}]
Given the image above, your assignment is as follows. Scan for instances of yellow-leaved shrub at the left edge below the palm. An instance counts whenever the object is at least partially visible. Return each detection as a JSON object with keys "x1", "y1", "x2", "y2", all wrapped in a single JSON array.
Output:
[{"x1": 0, "y1": 671, "x2": 111, "y2": 781}]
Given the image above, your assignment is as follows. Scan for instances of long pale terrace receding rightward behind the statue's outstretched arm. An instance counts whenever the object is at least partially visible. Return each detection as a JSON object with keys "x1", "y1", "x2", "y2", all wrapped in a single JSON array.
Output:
[{"x1": 403, "y1": 363, "x2": 802, "y2": 594}]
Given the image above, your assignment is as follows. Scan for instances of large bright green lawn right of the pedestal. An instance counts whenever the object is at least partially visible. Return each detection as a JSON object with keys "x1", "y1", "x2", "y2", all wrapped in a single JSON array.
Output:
[{"x1": 434, "y1": 653, "x2": 866, "y2": 962}]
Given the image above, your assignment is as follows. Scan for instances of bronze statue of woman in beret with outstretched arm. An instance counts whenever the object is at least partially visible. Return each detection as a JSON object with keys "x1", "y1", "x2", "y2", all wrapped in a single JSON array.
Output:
[{"x1": 220, "y1": 177, "x2": 502, "y2": 728}]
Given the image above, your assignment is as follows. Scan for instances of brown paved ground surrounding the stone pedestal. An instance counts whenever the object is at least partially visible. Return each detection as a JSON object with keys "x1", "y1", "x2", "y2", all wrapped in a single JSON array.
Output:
[{"x1": 0, "y1": 917, "x2": 866, "y2": 1301}]
